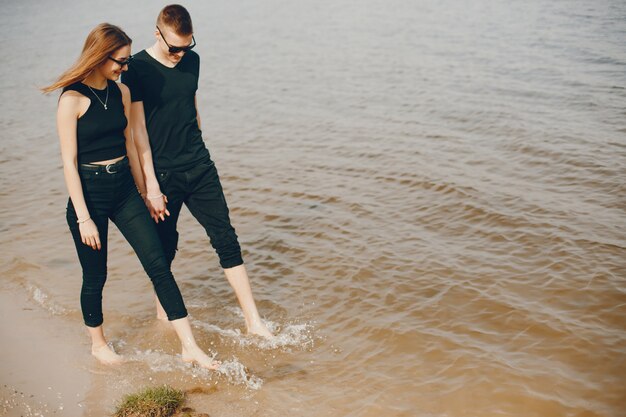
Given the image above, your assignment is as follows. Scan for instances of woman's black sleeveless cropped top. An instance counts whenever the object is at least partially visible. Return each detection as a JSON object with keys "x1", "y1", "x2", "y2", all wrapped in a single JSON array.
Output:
[{"x1": 63, "y1": 80, "x2": 128, "y2": 164}]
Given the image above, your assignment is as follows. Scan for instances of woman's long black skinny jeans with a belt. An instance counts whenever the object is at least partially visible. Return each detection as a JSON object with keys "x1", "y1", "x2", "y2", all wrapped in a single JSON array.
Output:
[{"x1": 67, "y1": 158, "x2": 187, "y2": 327}]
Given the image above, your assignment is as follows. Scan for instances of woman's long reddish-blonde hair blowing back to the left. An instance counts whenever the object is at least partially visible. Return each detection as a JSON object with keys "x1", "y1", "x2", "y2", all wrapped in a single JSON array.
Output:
[{"x1": 41, "y1": 23, "x2": 133, "y2": 93}]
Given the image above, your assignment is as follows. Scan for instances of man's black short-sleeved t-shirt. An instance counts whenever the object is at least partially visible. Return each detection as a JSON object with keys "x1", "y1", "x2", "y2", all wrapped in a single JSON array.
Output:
[{"x1": 122, "y1": 50, "x2": 210, "y2": 171}]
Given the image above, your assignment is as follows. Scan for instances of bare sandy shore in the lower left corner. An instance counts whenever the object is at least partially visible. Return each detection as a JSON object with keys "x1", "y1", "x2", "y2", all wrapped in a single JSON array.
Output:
[{"x1": 0, "y1": 285, "x2": 93, "y2": 417}]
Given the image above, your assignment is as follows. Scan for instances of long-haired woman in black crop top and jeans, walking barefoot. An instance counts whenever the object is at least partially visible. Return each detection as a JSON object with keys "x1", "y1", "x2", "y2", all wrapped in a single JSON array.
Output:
[{"x1": 43, "y1": 23, "x2": 219, "y2": 369}]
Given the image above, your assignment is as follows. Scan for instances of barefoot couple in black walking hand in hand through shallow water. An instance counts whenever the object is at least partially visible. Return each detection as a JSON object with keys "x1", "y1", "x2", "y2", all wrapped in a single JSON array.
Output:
[{"x1": 43, "y1": 5, "x2": 272, "y2": 369}]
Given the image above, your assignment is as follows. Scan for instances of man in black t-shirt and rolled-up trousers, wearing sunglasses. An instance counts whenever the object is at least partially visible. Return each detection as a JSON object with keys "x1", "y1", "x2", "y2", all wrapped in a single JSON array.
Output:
[{"x1": 122, "y1": 5, "x2": 272, "y2": 337}]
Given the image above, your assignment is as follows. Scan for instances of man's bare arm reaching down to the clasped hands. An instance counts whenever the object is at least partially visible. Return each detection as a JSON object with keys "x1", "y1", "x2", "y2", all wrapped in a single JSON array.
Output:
[{"x1": 130, "y1": 101, "x2": 170, "y2": 223}]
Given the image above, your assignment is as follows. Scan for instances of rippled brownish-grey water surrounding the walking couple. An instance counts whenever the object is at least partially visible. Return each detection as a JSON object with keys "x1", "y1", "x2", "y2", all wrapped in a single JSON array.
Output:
[{"x1": 0, "y1": 0, "x2": 626, "y2": 417}]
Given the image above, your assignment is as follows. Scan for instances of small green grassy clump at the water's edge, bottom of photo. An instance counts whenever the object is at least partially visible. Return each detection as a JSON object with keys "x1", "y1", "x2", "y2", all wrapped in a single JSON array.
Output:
[{"x1": 113, "y1": 385, "x2": 185, "y2": 417}]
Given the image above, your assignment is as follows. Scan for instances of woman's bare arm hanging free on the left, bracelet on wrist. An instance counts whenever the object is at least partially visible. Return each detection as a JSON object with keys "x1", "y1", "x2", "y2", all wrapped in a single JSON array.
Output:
[{"x1": 57, "y1": 91, "x2": 102, "y2": 250}]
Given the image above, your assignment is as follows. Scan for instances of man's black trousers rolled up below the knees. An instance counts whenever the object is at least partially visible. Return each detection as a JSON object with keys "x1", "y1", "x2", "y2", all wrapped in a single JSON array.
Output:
[{"x1": 156, "y1": 159, "x2": 243, "y2": 268}]
